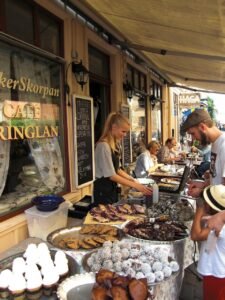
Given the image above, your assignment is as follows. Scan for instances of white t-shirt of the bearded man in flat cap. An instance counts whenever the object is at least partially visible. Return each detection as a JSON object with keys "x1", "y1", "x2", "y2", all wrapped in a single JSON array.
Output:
[{"x1": 210, "y1": 134, "x2": 225, "y2": 185}]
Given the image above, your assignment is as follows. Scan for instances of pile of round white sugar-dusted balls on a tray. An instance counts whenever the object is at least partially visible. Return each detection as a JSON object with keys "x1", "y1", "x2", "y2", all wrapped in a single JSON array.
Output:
[{"x1": 82, "y1": 241, "x2": 179, "y2": 285}]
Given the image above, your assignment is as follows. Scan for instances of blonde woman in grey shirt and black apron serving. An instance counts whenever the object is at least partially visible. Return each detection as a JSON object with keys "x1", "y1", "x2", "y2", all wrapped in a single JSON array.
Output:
[{"x1": 94, "y1": 112, "x2": 152, "y2": 205}]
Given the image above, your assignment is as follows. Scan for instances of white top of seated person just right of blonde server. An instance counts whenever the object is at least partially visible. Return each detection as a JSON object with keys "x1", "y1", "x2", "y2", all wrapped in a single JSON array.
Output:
[{"x1": 134, "y1": 150, "x2": 154, "y2": 178}]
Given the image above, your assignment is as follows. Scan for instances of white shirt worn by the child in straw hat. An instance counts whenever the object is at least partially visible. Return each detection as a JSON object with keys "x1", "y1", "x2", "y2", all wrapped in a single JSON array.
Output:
[{"x1": 197, "y1": 226, "x2": 225, "y2": 278}]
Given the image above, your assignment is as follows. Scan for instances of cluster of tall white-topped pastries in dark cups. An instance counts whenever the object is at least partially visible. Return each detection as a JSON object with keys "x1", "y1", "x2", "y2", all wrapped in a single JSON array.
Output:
[{"x1": 0, "y1": 243, "x2": 78, "y2": 299}]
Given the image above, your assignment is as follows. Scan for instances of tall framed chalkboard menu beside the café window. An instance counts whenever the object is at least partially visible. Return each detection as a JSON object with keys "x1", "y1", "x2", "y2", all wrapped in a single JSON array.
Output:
[{"x1": 73, "y1": 96, "x2": 94, "y2": 187}]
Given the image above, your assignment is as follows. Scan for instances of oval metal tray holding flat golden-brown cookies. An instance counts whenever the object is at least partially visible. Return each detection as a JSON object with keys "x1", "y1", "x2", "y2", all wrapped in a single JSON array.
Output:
[{"x1": 47, "y1": 224, "x2": 124, "y2": 251}]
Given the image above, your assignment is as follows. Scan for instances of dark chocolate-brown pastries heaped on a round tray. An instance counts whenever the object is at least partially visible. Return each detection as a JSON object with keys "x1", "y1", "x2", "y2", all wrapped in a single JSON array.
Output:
[{"x1": 124, "y1": 218, "x2": 188, "y2": 242}]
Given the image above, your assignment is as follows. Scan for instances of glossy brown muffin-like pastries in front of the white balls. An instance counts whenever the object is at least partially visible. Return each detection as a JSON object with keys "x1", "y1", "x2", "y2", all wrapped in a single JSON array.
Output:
[{"x1": 91, "y1": 269, "x2": 150, "y2": 300}]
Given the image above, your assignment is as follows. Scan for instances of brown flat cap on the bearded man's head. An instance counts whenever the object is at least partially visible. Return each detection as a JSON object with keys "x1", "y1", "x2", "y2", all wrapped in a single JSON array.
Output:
[{"x1": 181, "y1": 108, "x2": 212, "y2": 132}]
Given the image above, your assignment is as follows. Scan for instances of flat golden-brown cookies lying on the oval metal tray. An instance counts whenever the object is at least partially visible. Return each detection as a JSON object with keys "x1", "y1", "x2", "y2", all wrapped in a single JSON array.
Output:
[{"x1": 53, "y1": 224, "x2": 120, "y2": 250}]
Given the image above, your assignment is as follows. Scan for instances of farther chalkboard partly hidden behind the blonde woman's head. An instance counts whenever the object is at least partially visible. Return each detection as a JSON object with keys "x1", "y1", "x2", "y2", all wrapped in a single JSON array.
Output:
[{"x1": 121, "y1": 105, "x2": 132, "y2": 166}]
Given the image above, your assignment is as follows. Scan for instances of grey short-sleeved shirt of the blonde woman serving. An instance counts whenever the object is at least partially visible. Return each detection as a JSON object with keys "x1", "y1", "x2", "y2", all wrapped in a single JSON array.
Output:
[{"x1": 95, "y1": 142, "x2": 116, "y2": 178}]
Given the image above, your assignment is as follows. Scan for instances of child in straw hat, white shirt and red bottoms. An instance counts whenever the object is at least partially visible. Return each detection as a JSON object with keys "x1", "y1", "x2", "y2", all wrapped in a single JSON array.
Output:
[{"x1": 191, "y1": 184, "x2": 225, "y2": 300}]
